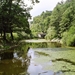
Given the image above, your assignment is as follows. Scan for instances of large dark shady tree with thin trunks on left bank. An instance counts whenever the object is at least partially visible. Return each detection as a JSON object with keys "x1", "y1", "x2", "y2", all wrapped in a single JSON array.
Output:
[{"x1": 0, "y1": 0, "x2": 38, "y2": 40}]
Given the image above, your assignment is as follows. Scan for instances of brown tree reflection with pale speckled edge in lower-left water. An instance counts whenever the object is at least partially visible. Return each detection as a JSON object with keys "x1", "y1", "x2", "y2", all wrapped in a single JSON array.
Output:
[{"x1": 0, "y1": 49, "x2": 30, "y2": 75}]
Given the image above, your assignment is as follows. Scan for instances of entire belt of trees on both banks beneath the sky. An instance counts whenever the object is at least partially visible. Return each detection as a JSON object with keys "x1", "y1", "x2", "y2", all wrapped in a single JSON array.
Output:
[{"x1": 0, "y1": 0, "x2": 75, "y2": 46}]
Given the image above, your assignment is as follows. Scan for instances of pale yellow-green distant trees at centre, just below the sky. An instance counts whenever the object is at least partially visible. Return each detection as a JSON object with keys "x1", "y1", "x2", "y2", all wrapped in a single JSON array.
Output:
[{"x1": 30, "y1": 11, "x2": 51, "y2": 37}]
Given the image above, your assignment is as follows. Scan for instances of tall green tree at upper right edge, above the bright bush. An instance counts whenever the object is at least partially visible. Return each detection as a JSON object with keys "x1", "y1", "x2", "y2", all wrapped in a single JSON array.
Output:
[{"x1": 60, "y1": 0, "x2": 75, "y2": 34}]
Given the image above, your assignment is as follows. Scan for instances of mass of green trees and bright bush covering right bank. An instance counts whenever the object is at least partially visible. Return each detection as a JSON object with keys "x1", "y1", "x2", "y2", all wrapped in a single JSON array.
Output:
[{"x1": 46, "y1": 0, "x2": 75, "y2": 46}]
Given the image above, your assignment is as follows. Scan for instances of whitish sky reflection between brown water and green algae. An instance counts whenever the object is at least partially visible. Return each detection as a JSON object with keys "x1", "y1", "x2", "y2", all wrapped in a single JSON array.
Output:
[{"x1": 27, "y1": 48, "x2": 62, "y2": 75}]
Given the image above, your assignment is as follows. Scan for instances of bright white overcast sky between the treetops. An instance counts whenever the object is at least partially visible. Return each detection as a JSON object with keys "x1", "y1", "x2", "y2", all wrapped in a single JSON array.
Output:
[{"x1": 30, "y1": 0, "x2": 65, "y2": 17}]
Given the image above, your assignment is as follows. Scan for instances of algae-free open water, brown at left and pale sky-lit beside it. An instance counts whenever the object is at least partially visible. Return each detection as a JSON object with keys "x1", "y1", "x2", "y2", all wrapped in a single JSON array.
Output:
[{"x1": 0, "y1": 48, "x2": 62, "y2": 75}]
